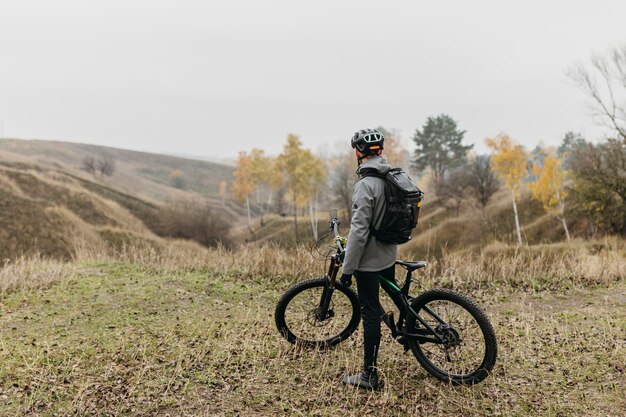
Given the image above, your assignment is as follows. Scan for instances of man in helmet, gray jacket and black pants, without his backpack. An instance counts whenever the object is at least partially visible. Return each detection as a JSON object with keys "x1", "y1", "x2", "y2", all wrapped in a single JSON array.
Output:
[{"x1": 340, "y1": 129, "x2": 398, "y2": 390}]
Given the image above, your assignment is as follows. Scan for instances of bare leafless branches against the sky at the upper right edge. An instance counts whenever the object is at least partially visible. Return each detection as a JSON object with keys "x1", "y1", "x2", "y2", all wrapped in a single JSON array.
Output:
[{"x1": 568, "y1": 44, "x2": 626, "y2": 143}]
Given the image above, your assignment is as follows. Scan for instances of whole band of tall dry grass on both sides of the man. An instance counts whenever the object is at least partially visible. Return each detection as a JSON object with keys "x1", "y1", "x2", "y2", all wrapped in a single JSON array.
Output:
[{"x1": 0, "y1": 234, "x2": 626, "y2": 292}]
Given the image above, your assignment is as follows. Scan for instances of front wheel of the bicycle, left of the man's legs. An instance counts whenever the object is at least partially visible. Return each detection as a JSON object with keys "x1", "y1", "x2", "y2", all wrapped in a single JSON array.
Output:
[{"x1": 274, "y1": 278, "x2": 361, "y2": 348}]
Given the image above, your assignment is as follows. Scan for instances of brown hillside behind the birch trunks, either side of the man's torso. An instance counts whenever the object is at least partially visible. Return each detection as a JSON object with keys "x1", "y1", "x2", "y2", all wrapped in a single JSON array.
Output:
[{"x1": 241, "y1": 187, "x2": 587, "y2": 259}]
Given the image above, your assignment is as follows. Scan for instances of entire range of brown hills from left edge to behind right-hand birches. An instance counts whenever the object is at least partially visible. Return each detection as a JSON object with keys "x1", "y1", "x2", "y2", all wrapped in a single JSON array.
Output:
[{"x1": 0, "y1": 139, "x2": 608, "y2": 258}]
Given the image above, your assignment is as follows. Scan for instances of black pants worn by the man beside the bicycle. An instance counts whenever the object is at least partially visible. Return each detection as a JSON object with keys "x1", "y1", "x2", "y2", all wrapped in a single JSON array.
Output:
[{"x1": 354, "y1": 265, "x2": 401, "y2": 369}]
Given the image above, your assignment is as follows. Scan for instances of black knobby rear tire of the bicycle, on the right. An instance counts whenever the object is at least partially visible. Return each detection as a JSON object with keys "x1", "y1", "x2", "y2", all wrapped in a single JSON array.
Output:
[{"x1": 406, "y1": 289, "x2": 498, "y2": 385}]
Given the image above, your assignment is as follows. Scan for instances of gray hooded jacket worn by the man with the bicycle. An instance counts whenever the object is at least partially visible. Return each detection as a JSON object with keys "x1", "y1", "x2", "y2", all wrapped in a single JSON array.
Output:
[{"x1": 343, "y1": 156, "x2": 398, "y2": 274}]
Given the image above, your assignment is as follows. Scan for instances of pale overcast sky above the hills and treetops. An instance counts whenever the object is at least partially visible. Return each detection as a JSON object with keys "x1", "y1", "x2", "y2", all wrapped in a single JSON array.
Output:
[{"x1": 0, "y1": 0, "x2": 626, "y2": 157}]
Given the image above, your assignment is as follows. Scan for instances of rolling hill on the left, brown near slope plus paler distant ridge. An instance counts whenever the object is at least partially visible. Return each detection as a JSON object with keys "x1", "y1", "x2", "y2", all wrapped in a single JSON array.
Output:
[{"x1": 0, "y1": 140, "x2": 241, "y2": 262}]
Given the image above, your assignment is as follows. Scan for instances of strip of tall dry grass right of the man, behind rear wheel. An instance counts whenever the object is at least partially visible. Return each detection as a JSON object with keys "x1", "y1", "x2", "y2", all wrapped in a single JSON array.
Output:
[{"x1": 404, "y1": 239, "x2": 626, "y2": 291}]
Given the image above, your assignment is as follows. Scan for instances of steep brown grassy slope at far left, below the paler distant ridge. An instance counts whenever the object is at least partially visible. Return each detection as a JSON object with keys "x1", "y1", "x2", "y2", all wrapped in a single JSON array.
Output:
[{"x1": 0, "y1": 159, "x2": 159, "y2": 261}]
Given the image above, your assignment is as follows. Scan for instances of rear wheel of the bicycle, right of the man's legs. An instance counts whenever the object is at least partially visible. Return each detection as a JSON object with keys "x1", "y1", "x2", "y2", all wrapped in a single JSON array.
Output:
[{"x1": 407, "y1": 289, "x2": 497, "y2": 385}]
